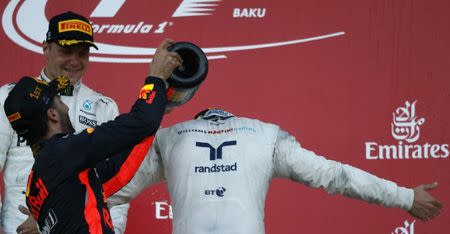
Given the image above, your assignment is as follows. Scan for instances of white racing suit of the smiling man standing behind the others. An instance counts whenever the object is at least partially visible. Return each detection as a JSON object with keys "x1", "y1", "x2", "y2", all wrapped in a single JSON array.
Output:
[{"x1": 0, "y1": 72, "x2": 129, "y2": 233}]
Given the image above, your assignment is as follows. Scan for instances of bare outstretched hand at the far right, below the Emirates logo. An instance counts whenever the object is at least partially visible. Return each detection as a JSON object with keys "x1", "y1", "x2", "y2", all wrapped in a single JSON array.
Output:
[{"x1": 408, "y1": 182, "x2": 442, "y2": 221}]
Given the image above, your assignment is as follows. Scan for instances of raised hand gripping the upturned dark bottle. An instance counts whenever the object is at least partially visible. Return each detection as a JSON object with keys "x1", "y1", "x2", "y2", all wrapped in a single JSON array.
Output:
[{"x1": 149, "y1": 39, "x2": 183, "y2": 80}]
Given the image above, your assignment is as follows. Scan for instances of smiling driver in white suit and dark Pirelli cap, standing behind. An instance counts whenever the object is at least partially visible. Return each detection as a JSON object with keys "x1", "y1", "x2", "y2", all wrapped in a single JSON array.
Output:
[{"x1": 0, "y1": 12, "x2": 129, "y2": 233}]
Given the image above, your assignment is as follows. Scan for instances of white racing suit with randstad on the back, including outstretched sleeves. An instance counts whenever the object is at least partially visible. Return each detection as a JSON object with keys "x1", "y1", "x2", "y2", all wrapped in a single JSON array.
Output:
[{"x1": 109, "y1": 110, "x2": 414, "y2": 234}]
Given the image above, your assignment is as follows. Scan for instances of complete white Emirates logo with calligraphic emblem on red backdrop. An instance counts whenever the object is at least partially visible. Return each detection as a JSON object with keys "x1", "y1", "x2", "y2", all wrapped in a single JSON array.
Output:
[{"x1": 366, "y1": 101, "x2": 449, "y2": 160}]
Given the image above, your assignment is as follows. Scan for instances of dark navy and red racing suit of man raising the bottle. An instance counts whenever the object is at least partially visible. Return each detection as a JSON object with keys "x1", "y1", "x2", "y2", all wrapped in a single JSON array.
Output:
[{"x1": 26, "y1": 77, "x2": 167, "y2": 233}]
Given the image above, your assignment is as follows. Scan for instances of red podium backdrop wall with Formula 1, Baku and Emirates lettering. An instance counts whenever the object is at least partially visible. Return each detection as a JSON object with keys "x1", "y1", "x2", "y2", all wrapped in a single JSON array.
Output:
[{"x1": 0, "y1": 0, "x2": 450, "y2": 234}]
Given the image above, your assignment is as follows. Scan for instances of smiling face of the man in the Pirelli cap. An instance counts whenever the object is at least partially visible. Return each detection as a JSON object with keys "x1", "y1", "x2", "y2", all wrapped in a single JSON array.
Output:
[{"x1": 44, "y1": 42, "x2": 89, "y2": 84}]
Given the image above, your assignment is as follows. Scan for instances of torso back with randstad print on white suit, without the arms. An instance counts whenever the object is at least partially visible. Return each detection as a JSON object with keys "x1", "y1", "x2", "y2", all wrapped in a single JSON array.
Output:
[{"x1": 156, "y1": 112, "x2": 278, "y2": 233}]
